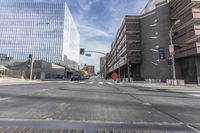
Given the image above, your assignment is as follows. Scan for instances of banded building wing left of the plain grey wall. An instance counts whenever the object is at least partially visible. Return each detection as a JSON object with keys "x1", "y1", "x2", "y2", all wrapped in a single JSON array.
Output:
[{"x1": 107, "y1": 16, "x2": 141, "y2": 79}]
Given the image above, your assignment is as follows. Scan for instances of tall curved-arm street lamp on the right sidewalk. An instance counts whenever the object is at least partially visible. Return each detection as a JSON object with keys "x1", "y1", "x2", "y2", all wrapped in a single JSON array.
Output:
[{"x1": 169, "y1": 19, "x2": 181, "y2": 80}]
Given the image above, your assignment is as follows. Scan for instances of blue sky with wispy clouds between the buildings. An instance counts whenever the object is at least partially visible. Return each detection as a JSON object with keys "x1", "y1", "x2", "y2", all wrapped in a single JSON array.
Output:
[{"x1": 67, "y1": 0, "x2": 148, "y2": 72}]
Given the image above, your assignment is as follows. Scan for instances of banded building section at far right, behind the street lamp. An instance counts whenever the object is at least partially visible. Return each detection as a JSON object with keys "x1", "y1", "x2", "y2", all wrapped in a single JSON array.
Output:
[{"x1": 169, "y1": 0, "x2": 200, "y2": 84}]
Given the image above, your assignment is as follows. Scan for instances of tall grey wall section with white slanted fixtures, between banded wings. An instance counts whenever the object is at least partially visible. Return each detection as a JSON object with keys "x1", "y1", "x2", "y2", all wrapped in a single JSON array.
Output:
[{"x1": 141, "y1": 4, "x2": 179, "y2": 81}]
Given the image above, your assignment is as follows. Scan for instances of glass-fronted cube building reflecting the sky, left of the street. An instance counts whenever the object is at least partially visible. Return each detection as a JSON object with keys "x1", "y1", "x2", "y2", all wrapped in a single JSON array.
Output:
[{"x1": 0, "y1": 0, "x2": 80, "y2": 63}]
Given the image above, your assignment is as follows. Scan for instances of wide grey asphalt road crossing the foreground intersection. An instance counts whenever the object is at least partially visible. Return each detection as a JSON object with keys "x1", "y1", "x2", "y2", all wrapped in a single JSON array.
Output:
[{"x1": 0, "y1": 79, "x2": 200, "y2": 129}]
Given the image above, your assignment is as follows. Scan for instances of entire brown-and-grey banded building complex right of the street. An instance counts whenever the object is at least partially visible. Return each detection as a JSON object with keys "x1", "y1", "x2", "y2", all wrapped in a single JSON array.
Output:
[{"x1": 106, "y1": 0, "x2": 200, "y2": 84}]
